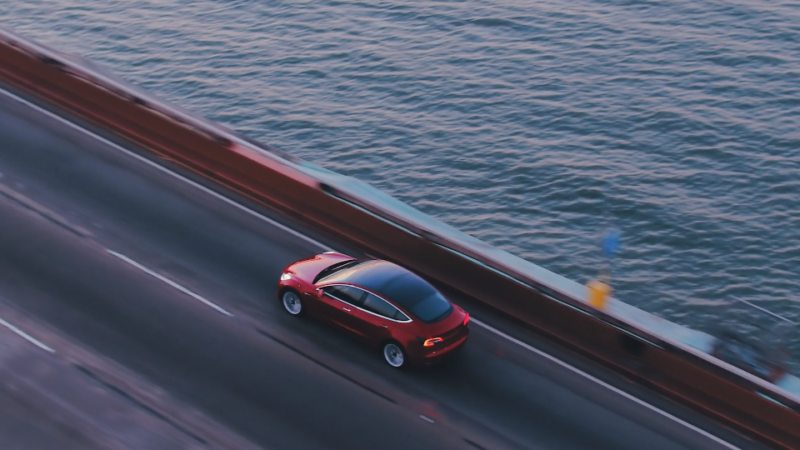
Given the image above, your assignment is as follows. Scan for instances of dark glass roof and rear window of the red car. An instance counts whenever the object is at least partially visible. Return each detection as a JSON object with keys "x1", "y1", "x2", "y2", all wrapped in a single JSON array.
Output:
[{"x1": 325, "y1": 261, "x2": 453, "y2": 323}]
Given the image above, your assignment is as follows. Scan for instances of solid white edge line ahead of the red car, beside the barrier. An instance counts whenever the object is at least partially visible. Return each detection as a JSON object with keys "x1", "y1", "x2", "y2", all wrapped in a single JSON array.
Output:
[{"x1": 0, "y1": 89, "x2": 332, "y2": 251}]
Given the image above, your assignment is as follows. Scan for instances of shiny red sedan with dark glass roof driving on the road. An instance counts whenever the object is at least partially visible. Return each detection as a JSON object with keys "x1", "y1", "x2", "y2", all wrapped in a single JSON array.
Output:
[{"x1": 278, "y1": 252, "x2": 469, "y2": 367}]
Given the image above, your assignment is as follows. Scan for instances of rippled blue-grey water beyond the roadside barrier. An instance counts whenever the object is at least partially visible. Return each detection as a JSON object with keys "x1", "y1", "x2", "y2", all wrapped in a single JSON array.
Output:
[{"x1": 0, "y1": 0, "x2": 800, "y2": 372}]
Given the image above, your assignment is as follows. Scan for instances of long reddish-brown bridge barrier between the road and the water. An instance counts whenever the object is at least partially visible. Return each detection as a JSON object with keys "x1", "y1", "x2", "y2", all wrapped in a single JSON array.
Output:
[{"x1": 0, "y1": 31, "x2": 800, "y2": 449}]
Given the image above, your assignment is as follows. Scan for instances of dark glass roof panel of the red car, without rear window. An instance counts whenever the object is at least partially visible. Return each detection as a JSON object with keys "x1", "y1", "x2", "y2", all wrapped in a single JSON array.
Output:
[{"x1": 325, "y1": 260, "x2": 437, "y2": 309}]
